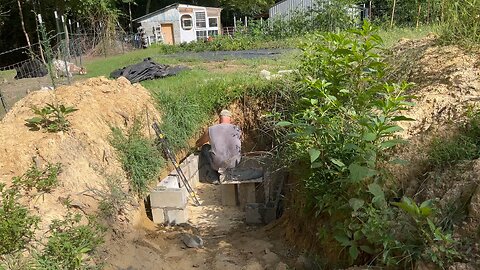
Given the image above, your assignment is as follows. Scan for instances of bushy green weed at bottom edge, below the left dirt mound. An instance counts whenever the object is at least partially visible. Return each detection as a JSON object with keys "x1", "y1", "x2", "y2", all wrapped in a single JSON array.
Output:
[{"x1": 36, "y1": 212, "x2": 104, "y2": 270}]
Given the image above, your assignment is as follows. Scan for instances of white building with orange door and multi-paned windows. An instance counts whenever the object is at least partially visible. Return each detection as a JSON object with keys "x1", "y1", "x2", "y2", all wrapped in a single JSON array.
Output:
[{"x1": 133, "y1": 3, "x2": 222, "y2": 45}]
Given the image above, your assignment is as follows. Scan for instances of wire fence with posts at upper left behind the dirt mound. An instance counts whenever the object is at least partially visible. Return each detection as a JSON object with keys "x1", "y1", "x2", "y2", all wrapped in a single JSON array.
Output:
[{"x1": 0, "y1": 25, "x2": 141, "y2": 118}]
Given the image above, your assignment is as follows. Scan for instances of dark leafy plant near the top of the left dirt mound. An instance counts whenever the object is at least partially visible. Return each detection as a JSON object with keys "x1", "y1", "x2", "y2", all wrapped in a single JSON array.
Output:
[{"x1": 25, "y1": 104, "x2": 78, "y2": 132}]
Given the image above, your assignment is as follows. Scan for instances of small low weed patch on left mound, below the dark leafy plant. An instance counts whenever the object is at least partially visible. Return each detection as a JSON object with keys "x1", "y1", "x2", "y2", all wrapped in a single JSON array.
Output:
[{"x1": 12, "y1": 163, "x2": 62, "y2": 192}]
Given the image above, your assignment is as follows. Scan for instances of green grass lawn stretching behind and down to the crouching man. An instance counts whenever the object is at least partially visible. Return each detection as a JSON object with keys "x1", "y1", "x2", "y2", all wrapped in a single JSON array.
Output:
[{"x1": 85, "y1": 24, "x2": 433, "y2": 152}]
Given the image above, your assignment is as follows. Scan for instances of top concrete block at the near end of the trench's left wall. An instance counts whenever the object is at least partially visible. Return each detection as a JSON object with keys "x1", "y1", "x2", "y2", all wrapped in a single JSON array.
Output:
[{"x1": 150, "y1": 188, "x2": 188, "y2": 209}]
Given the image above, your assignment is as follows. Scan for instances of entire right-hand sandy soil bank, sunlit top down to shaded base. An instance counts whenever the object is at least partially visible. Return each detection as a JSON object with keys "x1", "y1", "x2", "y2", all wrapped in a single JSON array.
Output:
[{"x1": 390, "y1": 36, "x2": 480, "y2": 269}]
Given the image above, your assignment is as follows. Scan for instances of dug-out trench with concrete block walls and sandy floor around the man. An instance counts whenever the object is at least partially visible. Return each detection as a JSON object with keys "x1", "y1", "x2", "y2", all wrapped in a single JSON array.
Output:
[{"x1": 104, "y1": 100, "x2": 305, "y2": 269}]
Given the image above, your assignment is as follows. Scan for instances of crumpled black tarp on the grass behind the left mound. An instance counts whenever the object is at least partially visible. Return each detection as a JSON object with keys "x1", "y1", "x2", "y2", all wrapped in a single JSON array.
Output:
[{"x1": 110, "y1": 58, "x2": 188, "y2": 83}]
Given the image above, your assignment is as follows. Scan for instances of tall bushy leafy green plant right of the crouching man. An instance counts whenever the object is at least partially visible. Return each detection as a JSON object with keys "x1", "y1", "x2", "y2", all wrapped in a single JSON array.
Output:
[{"x1": 278, "y1": 22, "x2": 458, "y2": 266}]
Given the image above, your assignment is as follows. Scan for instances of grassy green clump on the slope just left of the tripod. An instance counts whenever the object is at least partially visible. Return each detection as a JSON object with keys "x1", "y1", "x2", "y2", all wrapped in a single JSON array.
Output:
[{"x1": 110, "y1": 119, "x2": 164, "y2": 196}]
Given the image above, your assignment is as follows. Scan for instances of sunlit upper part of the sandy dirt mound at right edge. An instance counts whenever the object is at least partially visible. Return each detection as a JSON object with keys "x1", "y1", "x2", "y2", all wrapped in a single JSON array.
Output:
[{"x1": 390, "y1": 36, "x2": 480, "y2": 138}]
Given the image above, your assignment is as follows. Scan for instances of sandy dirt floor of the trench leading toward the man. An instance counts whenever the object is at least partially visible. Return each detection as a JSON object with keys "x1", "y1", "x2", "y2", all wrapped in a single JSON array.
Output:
[{"x1": 107, "y1": 181, "x2": 298, "y2": 270}]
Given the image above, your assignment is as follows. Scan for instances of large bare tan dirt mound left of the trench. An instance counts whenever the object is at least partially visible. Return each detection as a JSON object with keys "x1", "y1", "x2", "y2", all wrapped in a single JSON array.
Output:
[{"x1": 0, "y1": 77, "x2": 159, "y2": 231}]
